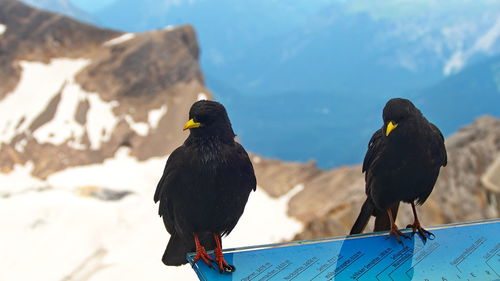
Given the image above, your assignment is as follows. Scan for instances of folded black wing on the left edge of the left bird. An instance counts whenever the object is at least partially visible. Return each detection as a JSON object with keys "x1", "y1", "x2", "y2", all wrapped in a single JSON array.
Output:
[{"x1": 154, "y1": 145, "x2": 186, "y2": 233}]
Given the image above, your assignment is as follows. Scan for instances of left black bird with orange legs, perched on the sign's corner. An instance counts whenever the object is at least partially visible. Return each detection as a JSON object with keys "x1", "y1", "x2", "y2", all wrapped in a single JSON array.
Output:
[{"x1": 154, "y1": 100, "x2": 257, "y2": 273}]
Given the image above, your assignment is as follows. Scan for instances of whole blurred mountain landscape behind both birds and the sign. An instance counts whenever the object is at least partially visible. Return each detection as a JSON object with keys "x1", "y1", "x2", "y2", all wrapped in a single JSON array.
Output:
[{"x1": 0, "y1": 0, "x2": 500, "y2": 281}]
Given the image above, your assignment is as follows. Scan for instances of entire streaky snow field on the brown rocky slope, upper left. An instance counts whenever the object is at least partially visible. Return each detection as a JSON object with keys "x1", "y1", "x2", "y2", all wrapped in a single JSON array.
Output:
[{"x1": 0, "y1": 58, "x2": 125, "y2": 151}]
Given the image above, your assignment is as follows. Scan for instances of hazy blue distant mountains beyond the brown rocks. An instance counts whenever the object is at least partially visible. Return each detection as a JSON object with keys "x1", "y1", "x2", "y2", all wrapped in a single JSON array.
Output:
[{"x1": 21, "y1": 0, "x2": 500, "y2": 168}]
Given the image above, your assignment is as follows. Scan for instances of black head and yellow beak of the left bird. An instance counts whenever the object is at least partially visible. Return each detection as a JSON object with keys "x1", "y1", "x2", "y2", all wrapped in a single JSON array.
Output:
[{"x1": 183, "y1": 100, "x2": 235, "y2": 138}]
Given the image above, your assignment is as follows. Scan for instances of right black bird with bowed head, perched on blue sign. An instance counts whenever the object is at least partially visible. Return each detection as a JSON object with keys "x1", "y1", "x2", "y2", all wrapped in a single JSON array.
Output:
[{"x1": 350, "y1": 98, "x2": 447, "y2": 242}]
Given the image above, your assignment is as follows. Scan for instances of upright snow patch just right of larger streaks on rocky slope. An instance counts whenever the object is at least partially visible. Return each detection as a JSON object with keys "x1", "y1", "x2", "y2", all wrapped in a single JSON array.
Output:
[{"x1": 86, "y1": 93, "x2": 118, "y2": 150}]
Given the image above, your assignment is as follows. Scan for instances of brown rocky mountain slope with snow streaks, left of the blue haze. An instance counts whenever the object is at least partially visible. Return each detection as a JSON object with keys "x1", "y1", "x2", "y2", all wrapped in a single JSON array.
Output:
[{"x1": 0, "y1": 0, "x2": 211, "y2": 178}]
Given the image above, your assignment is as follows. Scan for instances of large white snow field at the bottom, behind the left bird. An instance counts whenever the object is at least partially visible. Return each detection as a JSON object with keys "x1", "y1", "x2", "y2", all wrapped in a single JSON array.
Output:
[{"x1": 0, "y1": 148, "x2": 302, "y2": 281}]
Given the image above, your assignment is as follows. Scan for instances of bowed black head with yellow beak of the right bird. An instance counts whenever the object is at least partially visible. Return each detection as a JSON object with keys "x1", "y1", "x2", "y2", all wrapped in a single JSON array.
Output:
[{"x1": 382, "y1": 98, "x2": 422, "y2": 136}]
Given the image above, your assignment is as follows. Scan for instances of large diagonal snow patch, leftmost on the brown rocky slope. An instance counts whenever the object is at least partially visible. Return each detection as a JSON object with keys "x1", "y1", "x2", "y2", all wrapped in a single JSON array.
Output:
[{"x1": 0, "y1": 58, "x2": 90, "y2": 143}]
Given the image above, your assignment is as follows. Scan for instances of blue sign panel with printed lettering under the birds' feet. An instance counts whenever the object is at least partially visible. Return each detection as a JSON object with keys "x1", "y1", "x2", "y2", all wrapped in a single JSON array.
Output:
[{"x1": 188, "y1": 219, "x2": 500, "y2": 281}]
